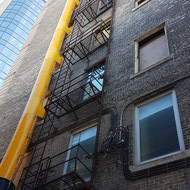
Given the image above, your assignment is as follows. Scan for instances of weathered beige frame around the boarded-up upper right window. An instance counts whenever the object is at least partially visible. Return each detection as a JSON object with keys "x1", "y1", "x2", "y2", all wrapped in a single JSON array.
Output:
[{"x1": 134, "y1": 23, "x2": 170, "y2": 74}]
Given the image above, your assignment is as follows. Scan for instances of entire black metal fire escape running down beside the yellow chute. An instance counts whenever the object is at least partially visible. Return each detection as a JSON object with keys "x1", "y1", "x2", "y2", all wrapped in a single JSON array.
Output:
[{"x1": 19, "y1": 0, "x2": 112, "y2": 190}]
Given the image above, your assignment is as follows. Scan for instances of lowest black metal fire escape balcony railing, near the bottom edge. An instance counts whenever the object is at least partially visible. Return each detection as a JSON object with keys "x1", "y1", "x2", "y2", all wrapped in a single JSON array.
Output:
[{"x1": 20, "y1": 144, "x2": 94, "y2": 190}]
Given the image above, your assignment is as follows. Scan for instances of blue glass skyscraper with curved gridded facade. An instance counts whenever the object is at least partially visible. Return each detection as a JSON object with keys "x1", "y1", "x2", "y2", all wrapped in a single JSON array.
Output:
[{"x1": 0, "y1": 0, "x2": 45, "y2": 87}]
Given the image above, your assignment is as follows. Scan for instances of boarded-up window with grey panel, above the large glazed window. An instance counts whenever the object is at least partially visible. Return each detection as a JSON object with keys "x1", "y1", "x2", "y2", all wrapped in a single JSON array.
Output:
[{"x1": 135, "y1": 27, "x2": 169, "y2": 72}]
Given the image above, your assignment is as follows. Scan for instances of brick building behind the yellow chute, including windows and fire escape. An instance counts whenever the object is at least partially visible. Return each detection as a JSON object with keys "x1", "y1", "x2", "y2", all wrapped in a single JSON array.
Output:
[{"x1": 0, "y1": 0, "x2": 190, "y2": 190}]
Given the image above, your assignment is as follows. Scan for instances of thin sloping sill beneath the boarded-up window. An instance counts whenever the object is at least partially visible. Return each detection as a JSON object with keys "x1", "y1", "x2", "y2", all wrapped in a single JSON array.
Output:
[{"x1": 130, "y1": 54, "x2": 173, "y2": 79}]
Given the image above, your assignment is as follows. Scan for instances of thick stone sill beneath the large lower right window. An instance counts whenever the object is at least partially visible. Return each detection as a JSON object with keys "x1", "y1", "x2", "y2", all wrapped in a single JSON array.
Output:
[{"x1": 130, "y1": 149, "x2": 190, "y2": 172}]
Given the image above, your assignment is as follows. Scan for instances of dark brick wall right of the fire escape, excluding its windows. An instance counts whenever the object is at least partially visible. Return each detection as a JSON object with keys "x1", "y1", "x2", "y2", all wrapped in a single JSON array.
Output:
[{"x1": 94, "y1": 0, "x2": 190, "y2": 190}]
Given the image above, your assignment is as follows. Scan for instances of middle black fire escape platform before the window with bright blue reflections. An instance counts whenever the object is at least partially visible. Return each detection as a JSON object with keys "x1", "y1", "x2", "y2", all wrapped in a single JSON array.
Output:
[{"x1": 46, "y1": 73, "x2": 102, "y2": 118}]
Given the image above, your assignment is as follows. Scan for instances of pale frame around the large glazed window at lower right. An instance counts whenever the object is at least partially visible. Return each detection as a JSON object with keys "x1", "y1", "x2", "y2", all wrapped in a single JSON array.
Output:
[{"x1": 134, "y1": 90, "x2": 185, "y2": 165}]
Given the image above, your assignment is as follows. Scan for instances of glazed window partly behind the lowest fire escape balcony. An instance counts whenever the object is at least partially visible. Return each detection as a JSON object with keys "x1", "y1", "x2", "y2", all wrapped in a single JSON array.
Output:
[{"x1": 64, "y1": 126, "x2": 97, "y2": 181}]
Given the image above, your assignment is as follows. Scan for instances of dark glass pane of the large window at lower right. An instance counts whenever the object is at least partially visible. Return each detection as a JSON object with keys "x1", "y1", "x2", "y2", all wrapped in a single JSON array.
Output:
[{"x1": 139, "y1": 95, "x2": 180, "y2": 161}]
